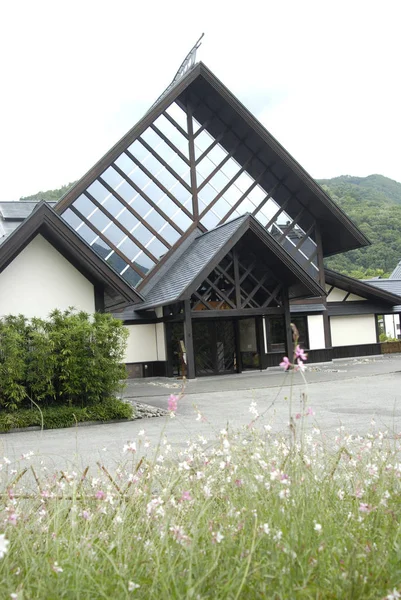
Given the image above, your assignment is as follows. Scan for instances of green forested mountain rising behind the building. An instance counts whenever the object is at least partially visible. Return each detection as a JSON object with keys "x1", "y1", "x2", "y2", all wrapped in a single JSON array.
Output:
[{"x1": 20, "y1": 175, "x2": 401, "y2": 279}]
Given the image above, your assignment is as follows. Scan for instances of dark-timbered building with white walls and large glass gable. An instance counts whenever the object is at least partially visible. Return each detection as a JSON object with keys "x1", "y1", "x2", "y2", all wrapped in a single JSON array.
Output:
[{"x1": 0, "y1": 56, "x2": 401, "y2": 377}]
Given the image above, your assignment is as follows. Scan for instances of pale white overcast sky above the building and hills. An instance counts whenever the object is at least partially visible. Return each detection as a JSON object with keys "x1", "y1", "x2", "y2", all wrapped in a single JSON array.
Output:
[{"x1": 0, "y1": 0, "x2": 401, "y2": 200}]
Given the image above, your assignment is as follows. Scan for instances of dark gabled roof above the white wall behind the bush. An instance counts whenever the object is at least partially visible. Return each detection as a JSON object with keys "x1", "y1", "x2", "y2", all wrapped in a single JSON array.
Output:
[{"x1": 0, "y1": 201, "x2": 142, "y2": 308}]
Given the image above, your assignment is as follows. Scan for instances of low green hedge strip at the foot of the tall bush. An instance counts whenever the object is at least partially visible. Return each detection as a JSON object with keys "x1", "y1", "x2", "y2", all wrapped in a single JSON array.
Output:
[{"x1": 0, "y1": 398, "x2": 133, "y2": 432}]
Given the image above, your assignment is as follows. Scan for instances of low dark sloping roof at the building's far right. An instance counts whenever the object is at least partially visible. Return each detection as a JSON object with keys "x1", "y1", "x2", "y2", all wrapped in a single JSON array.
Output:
[{"x1": 324, "y1": 269, "x2": 401, "y2": 306}]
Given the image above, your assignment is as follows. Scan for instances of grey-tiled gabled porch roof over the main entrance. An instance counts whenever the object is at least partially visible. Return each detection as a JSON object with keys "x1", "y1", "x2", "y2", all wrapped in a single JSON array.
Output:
[{"x1": 135, "y1": 214, "x2": 324, "y2": 310}]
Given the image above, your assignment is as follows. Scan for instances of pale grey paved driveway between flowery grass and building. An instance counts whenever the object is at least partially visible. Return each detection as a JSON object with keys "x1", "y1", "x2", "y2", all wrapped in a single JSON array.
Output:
[{"x1": 0, "y1": 355, "x2": 401, "y2": 470}]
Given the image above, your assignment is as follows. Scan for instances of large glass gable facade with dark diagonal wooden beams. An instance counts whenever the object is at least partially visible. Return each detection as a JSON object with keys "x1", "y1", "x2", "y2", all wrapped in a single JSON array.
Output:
[{"x1": 58, "y1": 78, "x2": 319, "y2": 287}]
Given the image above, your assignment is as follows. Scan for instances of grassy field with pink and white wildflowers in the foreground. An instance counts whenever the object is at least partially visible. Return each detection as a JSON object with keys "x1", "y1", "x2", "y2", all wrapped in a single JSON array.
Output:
[{"x1": 0, "y1": 402, "x2": 401, "y2": 600}]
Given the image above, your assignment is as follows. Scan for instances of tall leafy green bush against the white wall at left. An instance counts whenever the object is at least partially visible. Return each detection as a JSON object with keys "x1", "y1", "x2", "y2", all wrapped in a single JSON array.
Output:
[{"x1": 0, "y1": 310, "x2": 128, "y2": 410}]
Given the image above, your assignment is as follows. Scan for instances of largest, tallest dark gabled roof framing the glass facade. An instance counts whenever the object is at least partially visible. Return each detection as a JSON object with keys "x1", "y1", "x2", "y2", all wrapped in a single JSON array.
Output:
[{"x1": 56, "y1": 63, "x2": 369, "y2": 256}]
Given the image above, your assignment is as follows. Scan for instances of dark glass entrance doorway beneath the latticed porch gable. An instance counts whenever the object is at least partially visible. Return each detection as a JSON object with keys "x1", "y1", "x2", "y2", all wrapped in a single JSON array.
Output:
[{"x1": 192, "y1": 319, "x2": 237, "y2": 377}]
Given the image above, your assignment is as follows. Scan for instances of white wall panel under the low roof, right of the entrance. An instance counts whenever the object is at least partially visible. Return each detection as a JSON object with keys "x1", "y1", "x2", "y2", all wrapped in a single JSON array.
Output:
[{"x1": 330, "y1": 315, "x2": 377, "y2": 346}]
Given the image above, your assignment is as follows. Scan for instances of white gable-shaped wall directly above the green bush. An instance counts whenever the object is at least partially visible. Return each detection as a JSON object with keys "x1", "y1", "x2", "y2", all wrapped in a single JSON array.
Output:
[{"x1": 0, "y1": 235, "x2": 95, "y2": 318}]
